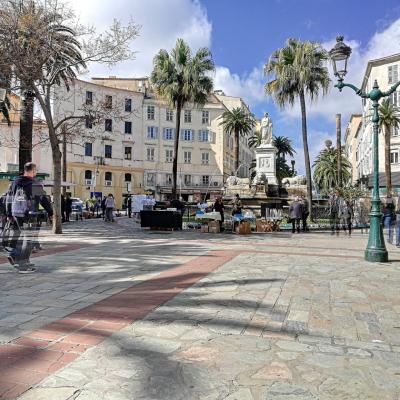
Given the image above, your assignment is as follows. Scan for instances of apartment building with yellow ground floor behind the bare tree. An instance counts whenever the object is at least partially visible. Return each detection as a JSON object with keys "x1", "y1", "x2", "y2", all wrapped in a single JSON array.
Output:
[{"x1": 54, "y1": 80, "x2": 144, "y2": 208}]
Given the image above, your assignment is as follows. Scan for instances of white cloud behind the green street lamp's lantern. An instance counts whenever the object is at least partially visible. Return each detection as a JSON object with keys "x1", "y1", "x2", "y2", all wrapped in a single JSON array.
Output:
[{"x1": 282, "y1": 19, "x2": 400, "y2": 121}]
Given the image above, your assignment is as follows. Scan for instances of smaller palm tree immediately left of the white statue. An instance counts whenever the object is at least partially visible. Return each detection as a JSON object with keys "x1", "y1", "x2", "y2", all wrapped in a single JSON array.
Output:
[{"x1": 220, "y1": 107, "x2": 256, "y2": 171}]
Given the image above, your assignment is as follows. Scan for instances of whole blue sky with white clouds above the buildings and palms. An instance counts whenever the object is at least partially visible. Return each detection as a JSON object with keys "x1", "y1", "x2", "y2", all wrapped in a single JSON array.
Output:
[{"x1": 67, "y1": 0, "x2": 400, "y2": 173}]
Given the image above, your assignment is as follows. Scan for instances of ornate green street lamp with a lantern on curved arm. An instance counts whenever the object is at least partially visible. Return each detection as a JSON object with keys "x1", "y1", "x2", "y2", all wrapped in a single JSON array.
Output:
[{"x1": 329, "y1": 36, "x2": 400, "y2": 262}]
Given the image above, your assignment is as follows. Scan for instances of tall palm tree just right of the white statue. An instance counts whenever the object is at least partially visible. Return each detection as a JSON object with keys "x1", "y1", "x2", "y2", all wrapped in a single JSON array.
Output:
[{"x1": 264, "y1": 39, "x2": 330, "y2": 210}]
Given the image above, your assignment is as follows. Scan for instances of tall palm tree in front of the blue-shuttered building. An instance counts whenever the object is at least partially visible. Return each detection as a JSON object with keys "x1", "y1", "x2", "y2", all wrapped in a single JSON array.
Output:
[{"x1": 150, "y1": 39, "x2": 214, "y2": 199}]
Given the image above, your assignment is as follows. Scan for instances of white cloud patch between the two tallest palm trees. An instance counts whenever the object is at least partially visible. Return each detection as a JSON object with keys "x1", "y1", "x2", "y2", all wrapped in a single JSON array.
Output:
[{"x1": 214, "y1": 67, "x2": 266, "y2": 106}]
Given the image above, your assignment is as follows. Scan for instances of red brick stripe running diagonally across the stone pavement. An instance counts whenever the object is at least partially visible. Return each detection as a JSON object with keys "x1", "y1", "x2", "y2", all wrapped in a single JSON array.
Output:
[{"x1": 0, "y1": 245, "x2": 241, "y2": 399}]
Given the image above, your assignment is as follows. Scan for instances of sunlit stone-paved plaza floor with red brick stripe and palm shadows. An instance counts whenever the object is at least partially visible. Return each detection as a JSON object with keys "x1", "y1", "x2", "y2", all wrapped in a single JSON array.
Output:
[{"x1": 0, "y1": 218, "x2": 400, "y2": 400}]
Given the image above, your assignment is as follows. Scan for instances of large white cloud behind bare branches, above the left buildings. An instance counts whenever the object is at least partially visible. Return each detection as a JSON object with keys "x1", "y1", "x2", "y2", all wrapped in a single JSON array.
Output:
[{"x1": 69, "y1": 0, "x2": 212, "y2": 76}]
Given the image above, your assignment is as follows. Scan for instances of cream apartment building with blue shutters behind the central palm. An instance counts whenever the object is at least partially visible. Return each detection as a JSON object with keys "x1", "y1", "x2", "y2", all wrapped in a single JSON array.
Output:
[{"x1": 92, "y1": 77, "x2": 254, "y2": 201}]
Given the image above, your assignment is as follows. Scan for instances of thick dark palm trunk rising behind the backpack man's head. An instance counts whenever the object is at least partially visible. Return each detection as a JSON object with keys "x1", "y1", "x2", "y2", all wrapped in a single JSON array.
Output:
[{"x1": 18, "y1": 87, "x2": 35, "y2": 173}]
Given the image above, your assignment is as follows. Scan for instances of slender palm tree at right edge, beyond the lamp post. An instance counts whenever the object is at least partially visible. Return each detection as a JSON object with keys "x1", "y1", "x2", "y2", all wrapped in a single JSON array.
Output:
[{"x1": 379, "y1": 99, "x2": 400, "y2": 194}]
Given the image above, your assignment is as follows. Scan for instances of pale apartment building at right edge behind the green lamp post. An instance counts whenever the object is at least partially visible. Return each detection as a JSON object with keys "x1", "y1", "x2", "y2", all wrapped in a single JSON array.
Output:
[{"x1": 351, "y1": 54, "x2": 400, "y2": 183}]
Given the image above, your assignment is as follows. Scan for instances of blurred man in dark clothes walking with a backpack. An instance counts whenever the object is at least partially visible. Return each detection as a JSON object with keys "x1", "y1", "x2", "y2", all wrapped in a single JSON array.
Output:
[{"x1": 7, "y1": 162, "x2": 53, "y2": 274}]
